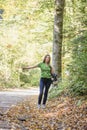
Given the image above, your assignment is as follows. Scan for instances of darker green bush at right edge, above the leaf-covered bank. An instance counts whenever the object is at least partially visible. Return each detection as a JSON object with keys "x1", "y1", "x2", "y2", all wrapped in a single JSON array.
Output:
[{"x1": 69, "y1": 32, "x2": 87, "y2": 95}]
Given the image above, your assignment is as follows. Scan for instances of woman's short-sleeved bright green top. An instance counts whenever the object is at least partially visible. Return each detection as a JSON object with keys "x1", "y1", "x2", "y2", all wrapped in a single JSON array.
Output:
[{"x1": 38, "y1": 62, "x2": 51, "y2": 78}]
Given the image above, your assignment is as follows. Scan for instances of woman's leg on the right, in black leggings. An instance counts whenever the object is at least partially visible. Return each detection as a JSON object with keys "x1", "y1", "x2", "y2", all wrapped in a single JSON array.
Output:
[{"x1": 43, "y1": 79, "x2": 51, "y2": 105}]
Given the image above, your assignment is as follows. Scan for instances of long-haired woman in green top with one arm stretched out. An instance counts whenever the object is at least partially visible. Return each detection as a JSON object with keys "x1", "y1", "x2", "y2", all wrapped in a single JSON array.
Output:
[{"x1": 23, "y1": 54, "x2": 53, "y2": 108}]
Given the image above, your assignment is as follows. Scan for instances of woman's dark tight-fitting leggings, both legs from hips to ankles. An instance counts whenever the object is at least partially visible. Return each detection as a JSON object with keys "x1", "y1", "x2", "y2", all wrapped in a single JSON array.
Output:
[{"x1": 38, "y1": 78, "x2": 52, "y2": 105}]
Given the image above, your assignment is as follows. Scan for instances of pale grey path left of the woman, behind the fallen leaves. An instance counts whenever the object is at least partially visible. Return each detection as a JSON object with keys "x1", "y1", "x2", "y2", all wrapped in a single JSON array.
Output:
[{"x1": 0, "y1": 88, "x2": 38, "y2": 113}]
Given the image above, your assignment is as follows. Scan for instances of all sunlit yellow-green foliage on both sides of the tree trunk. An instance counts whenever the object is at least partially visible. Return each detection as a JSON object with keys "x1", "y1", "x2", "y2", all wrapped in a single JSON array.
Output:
[{"x1": 0, "y1": 0, "x2": 87, "y2": 97}]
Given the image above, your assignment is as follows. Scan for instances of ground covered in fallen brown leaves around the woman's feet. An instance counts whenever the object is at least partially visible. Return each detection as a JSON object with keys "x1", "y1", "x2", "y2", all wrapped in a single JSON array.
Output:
[{"x1": 0, "y1": 89, "x2": 87, "y2": 130}]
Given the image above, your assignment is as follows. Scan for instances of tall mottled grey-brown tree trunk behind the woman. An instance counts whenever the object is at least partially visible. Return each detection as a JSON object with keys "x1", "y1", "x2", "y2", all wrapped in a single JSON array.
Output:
[{"x1": 52, "y1": 0, "x2": 65, "y2": 79}]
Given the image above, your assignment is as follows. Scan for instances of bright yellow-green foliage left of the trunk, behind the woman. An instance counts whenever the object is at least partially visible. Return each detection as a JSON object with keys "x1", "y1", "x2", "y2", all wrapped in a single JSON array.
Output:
[{"x1": 0, "y1": 0, "x2": 53, "y2": 87}]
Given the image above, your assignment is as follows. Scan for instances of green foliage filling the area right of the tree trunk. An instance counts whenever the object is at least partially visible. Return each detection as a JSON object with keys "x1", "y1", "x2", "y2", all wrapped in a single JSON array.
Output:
[{"x1": 63, "y1": 0, "x2": 87, "y2": 95}]
